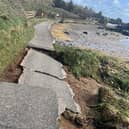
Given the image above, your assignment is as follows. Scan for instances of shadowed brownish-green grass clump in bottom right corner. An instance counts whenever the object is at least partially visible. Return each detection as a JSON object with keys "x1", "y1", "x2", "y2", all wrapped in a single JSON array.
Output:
[{"x1": 95, "y1": 87, "x2": 129, "y2": 129}]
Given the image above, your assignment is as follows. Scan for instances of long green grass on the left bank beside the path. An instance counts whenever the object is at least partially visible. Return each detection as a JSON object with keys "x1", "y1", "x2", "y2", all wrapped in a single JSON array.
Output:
[{"x1": 0, "y1": 18, "x2": 34, "y2": 74}]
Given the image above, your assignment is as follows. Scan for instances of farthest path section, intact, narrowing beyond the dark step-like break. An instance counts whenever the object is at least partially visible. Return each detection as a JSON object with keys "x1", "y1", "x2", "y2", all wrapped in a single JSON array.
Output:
[{"x1": 28, "y1": 22, "x2": 54, "y2": 51}]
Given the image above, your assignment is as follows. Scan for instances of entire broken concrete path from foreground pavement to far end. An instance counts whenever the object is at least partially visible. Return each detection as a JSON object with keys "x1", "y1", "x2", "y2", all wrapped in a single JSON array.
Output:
[{"x1": 0, "y1": 23, "x2": 80, "y2": 129}]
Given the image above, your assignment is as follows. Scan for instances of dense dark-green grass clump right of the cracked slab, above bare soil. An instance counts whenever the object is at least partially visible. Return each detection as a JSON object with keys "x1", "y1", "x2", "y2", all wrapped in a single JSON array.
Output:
[{"x1": 55, "y1": 45, "x2": 100, "y2": 80}]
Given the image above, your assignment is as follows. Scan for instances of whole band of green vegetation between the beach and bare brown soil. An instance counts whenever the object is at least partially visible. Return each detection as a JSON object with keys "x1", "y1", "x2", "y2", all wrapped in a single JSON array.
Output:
[{"x1": 55, "y1": 45, "x2": 129, "y2": 92}]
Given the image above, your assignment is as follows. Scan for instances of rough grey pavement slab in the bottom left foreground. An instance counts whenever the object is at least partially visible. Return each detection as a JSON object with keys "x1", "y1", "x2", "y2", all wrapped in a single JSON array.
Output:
[{"x1": 0, "y1": 83, "x2": 58, "y2": 129}]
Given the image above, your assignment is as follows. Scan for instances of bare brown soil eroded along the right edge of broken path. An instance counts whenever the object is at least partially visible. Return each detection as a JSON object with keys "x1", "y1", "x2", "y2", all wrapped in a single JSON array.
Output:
[{"x1": 61, "y1": 70, "x2": 102, "y2": 129}]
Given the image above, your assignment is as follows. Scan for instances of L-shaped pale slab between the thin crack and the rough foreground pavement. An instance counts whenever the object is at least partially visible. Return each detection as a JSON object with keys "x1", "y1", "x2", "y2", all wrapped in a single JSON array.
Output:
[{"x1": 19, "y1": 70, "x2": 80, "y2": 116}]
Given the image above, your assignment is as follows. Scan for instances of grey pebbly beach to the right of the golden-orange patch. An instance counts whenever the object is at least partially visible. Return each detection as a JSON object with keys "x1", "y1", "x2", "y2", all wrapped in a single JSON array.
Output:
[{"x1": 61, "y1": 24, "x2": 129, "y2": 61}]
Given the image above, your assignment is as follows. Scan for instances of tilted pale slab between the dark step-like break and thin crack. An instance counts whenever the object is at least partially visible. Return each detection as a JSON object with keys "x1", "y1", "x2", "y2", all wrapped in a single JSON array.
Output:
[{"x1": 21, "y1": 49, "x2": 66, "y2": 79}]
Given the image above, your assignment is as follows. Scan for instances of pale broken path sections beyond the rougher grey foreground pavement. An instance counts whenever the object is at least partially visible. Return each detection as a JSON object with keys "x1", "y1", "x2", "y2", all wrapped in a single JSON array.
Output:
[{"x1": 19, "y1": 23, "x2": 80, "y2": 129}]
